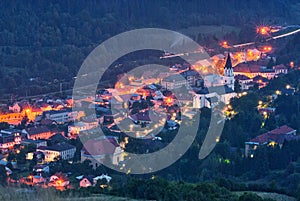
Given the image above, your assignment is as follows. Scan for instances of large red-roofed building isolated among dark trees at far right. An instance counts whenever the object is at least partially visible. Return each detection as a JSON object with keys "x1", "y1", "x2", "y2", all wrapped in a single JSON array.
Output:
[{"x1": 245, "y1": 125, "x2": 300, "y2": 158}]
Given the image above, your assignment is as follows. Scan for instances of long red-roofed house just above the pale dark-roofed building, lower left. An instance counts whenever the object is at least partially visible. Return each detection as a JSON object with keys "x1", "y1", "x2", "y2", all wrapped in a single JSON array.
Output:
[{"x1": 22, "y1": 126, "x2": 56, "y2": 140}]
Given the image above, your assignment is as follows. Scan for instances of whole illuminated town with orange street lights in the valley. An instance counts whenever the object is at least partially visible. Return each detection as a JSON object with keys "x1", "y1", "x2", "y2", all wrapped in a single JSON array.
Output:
[{"x1": 0, "y1": 37, "x2": 300, "y2": 190}]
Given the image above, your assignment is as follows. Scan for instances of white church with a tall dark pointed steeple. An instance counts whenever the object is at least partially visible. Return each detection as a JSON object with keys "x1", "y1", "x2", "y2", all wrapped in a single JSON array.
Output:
[{"x1": 193, "y1": 53, "x2": 237, "y2": 108}]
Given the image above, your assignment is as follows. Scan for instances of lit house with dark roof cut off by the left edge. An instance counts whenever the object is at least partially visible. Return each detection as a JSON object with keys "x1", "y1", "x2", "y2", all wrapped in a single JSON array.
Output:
[{"x1": 0, "y1": 129, "x2": 21, "y2": 150}]
